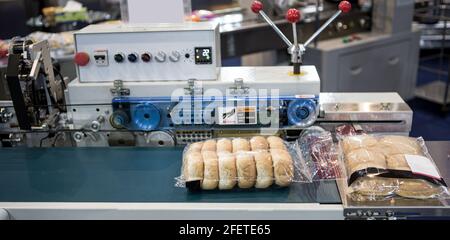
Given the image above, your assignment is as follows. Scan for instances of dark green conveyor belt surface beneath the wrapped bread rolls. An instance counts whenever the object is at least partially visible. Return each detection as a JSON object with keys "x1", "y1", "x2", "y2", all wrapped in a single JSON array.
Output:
[{"x1": 0, "y1": 148, "x2": 341, "y2": 203}]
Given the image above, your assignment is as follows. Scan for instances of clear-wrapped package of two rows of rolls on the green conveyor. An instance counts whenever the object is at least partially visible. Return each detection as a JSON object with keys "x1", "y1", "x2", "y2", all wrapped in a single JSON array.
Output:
[{"x1": 176, "y1": 136, "x2": 311, "y2": 191}]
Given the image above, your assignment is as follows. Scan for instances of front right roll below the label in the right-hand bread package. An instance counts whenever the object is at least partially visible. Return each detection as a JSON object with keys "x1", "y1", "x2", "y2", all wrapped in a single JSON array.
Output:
[{"x1": 396, "y1": 179, "x2": 444, "y2": 199}]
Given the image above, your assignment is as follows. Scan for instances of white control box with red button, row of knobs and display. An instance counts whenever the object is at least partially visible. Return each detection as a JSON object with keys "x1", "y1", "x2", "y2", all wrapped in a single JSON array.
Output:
[{"x1": 75, "y1": 23, "x2": 221, "y2": 82}]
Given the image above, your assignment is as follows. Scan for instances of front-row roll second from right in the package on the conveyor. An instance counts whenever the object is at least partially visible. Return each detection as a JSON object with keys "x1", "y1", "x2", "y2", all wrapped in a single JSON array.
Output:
[{"x1": 254, "y1": 151, "x2": 273, "y2": 188}]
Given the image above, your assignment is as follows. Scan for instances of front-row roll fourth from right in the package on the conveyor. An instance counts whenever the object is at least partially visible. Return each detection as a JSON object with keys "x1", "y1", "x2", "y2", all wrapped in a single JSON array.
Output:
[{"x1": 219, "y1": 154, "x2": 237, "y2": 190}]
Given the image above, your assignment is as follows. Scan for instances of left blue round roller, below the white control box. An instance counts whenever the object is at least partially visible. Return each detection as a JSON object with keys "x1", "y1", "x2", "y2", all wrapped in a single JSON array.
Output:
[{"x1": 132, "y1": 103, "x2": 161, "y2": 131}]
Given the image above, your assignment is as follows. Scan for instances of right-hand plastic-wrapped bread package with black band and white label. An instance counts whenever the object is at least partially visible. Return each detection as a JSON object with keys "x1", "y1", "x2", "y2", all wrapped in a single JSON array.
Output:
[{"x1": 339, "y1": 133, "x2": 449, "y2": 201}]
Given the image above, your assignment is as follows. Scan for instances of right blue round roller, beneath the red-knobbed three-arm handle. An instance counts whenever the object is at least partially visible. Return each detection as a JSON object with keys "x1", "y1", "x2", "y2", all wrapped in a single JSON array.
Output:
[{"x1": 287, "y1": 99, "x2": 317, "y2": 127}]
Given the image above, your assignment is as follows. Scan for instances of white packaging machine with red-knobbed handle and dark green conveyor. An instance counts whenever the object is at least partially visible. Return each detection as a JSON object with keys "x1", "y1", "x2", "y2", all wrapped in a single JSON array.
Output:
[{"x1": 0, "y1": 1, "x2": 449, "y2": 219}]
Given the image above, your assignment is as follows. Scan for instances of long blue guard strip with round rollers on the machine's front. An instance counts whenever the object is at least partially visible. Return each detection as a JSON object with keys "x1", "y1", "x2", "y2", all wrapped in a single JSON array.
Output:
[{"x1": 110, "y1": 96, "x2": 318, "y2": 131}]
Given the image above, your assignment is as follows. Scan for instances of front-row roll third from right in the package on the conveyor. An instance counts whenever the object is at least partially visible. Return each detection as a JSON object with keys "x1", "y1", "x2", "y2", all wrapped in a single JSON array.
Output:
[{"x1": 236, "y1": 153, "x2": 256, "y2": 188}]
